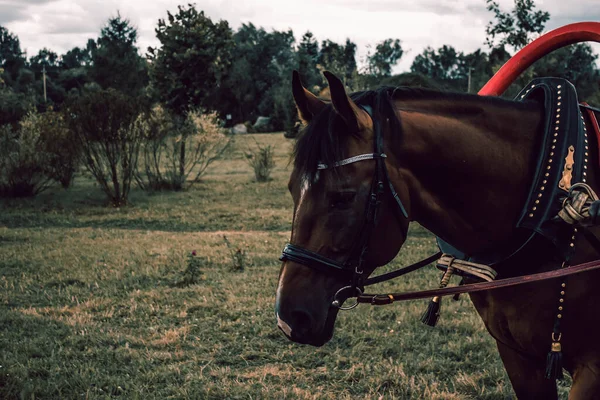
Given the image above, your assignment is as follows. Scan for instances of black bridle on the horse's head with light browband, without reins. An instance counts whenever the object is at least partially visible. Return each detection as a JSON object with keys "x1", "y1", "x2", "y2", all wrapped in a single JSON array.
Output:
[{"x1": 279, "y1": 106, "x2": 408, "y2": 309}]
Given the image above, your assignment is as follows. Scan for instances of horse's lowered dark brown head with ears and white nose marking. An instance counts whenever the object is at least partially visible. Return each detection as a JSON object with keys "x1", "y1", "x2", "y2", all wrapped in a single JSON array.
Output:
[{"x1": 276, "y1": 72, "x2": 409, "y2": 346}]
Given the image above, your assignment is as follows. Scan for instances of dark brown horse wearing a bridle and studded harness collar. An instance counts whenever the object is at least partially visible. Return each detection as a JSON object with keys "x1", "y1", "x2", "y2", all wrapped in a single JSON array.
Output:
[{"x1": 276, "y1": 73, "x2": 600, "y2": 399}]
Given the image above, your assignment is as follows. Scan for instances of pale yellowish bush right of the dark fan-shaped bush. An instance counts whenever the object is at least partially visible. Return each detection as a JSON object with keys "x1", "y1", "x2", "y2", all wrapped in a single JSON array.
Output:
[{"x1": 136, "y1": 106, "x2": 231, "y2": 191}]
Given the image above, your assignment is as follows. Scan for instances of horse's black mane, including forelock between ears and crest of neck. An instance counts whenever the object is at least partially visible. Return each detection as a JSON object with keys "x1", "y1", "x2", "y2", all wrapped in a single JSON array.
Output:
[{"x1": 294, "y1": 87, "x2": 531, "y2": 184}]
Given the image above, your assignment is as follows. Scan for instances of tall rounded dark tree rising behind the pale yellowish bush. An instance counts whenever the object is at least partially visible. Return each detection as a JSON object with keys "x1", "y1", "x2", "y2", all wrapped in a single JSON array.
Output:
[{"x1": 148, "y1": 5, "x2": 234, "y2": 116}]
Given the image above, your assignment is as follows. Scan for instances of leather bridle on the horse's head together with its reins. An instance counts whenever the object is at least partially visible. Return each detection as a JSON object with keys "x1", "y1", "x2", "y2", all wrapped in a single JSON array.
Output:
[{"x1": 279, "y1": 106, "x2": 600, "y2": 310}]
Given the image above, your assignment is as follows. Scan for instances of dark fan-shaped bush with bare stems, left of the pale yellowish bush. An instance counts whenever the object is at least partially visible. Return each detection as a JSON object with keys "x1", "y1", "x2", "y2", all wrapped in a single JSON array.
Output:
[{"x1": 67, "y1": 89, "x2": 143, "y2": 207}]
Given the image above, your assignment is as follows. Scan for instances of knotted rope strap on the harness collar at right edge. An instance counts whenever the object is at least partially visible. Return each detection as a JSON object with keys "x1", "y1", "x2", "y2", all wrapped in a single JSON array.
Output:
[{"x1": 558, "y1": 183, "x2": 600, "y2": 226}]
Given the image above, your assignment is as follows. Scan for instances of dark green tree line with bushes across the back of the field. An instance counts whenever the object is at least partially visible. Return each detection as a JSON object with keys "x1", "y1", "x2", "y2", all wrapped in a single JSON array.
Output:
[{"x1": 0, "y1": 0, "x2": 600, "y2": 204}]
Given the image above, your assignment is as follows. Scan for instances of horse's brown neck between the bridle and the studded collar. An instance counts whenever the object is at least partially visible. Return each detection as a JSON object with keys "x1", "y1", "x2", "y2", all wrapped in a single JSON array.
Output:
[{"x1": 397, "y1": 99, "x2": 543, "y2": 254}]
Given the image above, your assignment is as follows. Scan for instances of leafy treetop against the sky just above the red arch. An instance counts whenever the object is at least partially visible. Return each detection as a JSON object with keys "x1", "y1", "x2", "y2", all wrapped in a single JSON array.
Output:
[{"x1": 485, "y1": 0, "x2": 550, "y2": 49}]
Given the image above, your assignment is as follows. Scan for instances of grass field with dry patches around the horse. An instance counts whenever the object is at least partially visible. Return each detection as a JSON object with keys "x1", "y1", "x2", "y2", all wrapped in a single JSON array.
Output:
[{"x1": 0, "y1": 134, "x2": 568, "y2": 399}]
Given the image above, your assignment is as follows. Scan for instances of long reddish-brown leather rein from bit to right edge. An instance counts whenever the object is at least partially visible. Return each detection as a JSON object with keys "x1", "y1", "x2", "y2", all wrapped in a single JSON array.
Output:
[{"x1": 356, "y1": 260, "x2": 600, "y2": 306}]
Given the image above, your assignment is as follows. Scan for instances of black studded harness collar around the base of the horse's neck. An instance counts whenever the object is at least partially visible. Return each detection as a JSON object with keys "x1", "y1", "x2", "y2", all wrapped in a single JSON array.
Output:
[{"x1": 437, "y1": 78, "x2": 589, "y2": 266}]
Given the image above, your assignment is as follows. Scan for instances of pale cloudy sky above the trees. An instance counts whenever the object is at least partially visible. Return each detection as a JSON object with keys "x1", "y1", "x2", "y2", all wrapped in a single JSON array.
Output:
[{"x1": 0, "y1": 0, "x2": 600, "y2": 71}]
